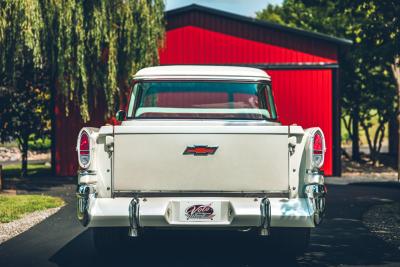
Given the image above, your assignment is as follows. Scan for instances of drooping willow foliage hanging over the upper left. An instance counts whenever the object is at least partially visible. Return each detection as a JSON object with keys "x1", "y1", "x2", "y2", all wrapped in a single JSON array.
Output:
[{"x1": 0, "y1": 0, "x2": 164, "y2": 121}]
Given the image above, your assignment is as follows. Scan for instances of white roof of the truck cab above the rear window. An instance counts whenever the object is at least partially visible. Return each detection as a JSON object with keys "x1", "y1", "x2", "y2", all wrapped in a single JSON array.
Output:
[{"x1": 134, "y1": 65, "x2": 271, "y2": 81}]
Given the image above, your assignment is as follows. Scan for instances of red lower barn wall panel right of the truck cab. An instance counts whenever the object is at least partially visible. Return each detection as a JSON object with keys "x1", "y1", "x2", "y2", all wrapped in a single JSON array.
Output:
[{"x1": 267, "y1": 69, "x2": 333, "y2": 175}]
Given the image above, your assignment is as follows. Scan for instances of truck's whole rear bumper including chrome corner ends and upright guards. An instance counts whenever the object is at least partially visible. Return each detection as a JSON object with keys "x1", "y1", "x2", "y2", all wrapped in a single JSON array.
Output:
[{"x1": 77, "y1": 181, "x2": 326, "y2": 236}]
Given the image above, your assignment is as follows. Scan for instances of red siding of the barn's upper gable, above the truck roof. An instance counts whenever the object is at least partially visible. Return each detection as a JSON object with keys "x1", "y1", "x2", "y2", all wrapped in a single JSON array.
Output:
[{"x1": 160, "y1": 26, "x2": 337, "y2": 64}]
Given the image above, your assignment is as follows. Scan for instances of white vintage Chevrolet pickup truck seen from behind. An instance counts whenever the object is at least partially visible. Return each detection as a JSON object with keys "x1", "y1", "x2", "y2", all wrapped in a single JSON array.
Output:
[{"x1": 77, "y1": 66, "x2": 326, "y2": 253}]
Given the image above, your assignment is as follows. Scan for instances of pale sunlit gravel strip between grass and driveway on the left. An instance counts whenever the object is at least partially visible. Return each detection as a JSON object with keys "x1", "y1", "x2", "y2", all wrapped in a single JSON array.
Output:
[{"x1": 0, "y1": 206, "x2": 62, "y2": 244}]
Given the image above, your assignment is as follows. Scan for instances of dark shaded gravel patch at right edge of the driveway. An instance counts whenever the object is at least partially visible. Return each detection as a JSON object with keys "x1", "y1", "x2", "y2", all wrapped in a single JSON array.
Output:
[{"x1": 363, "y1": 202, "x2": 400, "y2": 250}]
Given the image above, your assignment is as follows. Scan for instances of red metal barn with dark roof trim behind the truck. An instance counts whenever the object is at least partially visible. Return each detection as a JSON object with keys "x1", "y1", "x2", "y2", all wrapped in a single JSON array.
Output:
[{"x1": 52, "y1": 5, "x2": 351, "y2": 178}]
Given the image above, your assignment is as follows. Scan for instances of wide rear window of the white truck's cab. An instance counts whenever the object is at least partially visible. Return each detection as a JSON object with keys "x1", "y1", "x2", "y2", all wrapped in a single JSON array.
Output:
[{"x1": 128, "y1": 81, "x2": 276, "y2": 120}]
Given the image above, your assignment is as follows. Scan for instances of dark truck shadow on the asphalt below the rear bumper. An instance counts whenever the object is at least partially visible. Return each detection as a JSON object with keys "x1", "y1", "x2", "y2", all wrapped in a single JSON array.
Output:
[{"x1": 50, "y1": 230, "x2": 298, "y2": 266}]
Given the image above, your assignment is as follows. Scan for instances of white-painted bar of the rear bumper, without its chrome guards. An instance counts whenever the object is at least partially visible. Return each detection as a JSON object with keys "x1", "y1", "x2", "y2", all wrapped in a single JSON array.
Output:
[{"x1": 78, "y1": 196, "x2": 315, "y2": 229}]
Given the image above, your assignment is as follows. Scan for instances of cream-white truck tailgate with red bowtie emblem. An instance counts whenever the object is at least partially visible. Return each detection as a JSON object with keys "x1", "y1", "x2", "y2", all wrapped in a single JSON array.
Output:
[{"x1": 113, "y1": 125, "x2": 289, "y2": 192}]
